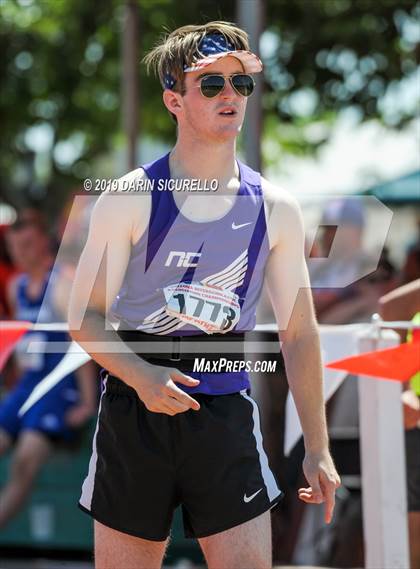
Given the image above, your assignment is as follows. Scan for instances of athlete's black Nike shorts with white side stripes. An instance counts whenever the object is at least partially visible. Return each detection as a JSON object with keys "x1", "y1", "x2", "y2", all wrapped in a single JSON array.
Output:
[{"x1": 79, "y1": 376, "x2": 282, "y2": 541}]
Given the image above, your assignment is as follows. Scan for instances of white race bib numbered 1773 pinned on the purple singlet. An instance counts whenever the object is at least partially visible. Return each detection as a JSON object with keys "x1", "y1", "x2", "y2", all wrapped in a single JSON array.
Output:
[{"x1": 163, "y1": 281, "x2": 241, "y2": 334}]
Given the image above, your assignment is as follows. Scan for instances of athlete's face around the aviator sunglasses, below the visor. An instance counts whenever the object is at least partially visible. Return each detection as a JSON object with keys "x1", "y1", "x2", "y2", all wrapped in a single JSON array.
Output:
[{"x1": 166, "y1": 56, "x2": 247, "y2": 141}]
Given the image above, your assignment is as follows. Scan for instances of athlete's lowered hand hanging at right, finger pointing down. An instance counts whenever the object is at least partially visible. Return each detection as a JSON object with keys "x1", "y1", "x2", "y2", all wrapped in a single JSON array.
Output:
[{"x1": 298, "y1": 450, "x2": 341, "y2": 524}]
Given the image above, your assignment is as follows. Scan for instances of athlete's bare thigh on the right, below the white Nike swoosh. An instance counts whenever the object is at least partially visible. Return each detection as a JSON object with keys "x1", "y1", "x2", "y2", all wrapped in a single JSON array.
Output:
[{"x1": 198, "y1": 511, "x2": 272, "y2": 569}]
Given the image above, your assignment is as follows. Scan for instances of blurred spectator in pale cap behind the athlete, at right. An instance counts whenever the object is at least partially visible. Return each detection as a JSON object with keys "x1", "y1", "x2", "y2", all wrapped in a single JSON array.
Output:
[{"x1": 310, "y1": 198, "x2": 396, "y2": 324}]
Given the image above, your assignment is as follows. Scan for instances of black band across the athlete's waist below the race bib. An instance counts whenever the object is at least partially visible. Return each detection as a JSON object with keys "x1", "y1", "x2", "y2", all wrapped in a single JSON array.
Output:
[{"x1": 118, "y1": 330, "x2": 245, "y2": 371}]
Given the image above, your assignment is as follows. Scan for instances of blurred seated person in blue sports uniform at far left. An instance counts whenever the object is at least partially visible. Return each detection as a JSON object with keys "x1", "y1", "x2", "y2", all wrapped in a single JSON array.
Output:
[{"x1": 0, "y1": 220, "x2": 96, "y2": 527}]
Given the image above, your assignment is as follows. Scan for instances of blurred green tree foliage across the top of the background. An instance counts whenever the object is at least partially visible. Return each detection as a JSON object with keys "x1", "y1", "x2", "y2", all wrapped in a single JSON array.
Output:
[{"x1": 0, "y1": 0, "x2": 420, "y2": 210}]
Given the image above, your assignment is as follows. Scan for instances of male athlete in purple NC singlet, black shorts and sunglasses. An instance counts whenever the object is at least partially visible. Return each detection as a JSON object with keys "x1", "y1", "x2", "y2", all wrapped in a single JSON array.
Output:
[{"x1": 69, "y1": 22, "x2": 340, "y2": 569}]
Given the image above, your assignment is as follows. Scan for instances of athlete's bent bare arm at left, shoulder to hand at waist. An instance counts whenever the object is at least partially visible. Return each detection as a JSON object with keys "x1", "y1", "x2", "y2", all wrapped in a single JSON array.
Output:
[{"x1": 68, "y1": 186, "x2": 200, "y2": 415}]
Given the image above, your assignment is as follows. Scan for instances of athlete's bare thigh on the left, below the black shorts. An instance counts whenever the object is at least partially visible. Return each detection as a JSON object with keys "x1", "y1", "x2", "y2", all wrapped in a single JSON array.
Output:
[{"x1": 94, "y1": 521, "x2": 167, "y2": 569}]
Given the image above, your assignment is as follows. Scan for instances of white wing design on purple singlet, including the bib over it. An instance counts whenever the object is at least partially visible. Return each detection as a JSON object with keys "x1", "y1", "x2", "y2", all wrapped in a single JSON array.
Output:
[{"x1": 137, "y1": 249, "x2": 248, "y2": 334}]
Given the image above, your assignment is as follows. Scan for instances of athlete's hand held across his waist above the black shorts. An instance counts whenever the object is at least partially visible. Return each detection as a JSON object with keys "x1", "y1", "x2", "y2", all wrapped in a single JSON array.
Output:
[{"x1": 131, "y1": 364, "x2": 200, "y2": 415}]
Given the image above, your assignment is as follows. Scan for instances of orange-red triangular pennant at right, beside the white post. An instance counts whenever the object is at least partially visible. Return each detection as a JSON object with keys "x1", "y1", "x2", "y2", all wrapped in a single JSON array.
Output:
[{"x1": 326, "y1": 342, "x2": 420, "y2": 382}]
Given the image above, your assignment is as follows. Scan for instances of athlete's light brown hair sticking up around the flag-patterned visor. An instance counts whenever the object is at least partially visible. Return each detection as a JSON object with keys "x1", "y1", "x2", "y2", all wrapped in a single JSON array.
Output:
[{"x1": 142, "y1": 21, "x2": 249, "y2": 95}]
